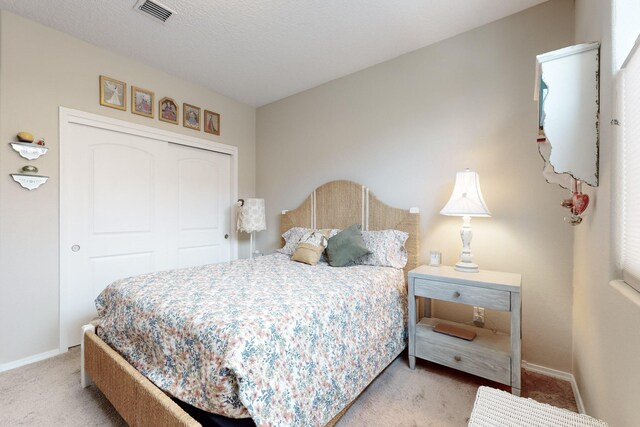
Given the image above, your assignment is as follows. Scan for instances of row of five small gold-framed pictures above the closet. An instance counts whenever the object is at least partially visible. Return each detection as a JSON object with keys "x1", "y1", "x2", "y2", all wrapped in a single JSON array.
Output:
[{"x1": 100, "y1": 75, "x2": 220, "y2": 135}]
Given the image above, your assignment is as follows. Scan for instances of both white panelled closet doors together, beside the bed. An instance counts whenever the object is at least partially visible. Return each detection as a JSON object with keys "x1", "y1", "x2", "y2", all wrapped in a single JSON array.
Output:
[{"x1": 61, "y1": 120, "x2": 232, "y2": 346}]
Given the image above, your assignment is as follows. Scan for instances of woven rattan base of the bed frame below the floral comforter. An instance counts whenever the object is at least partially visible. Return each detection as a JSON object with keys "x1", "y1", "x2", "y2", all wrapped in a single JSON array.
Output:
[{"x1": 82, "y1": 330, "x2": 353, "y2": 427}]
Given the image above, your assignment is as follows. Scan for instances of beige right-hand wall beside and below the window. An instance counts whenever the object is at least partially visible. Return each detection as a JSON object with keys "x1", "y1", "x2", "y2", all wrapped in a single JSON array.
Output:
[{"x1": 573, "y1": 0, "x2": 640, "y2": 427}]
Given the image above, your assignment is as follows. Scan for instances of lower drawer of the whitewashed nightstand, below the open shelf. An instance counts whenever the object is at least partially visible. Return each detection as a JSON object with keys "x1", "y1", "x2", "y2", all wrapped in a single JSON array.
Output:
[{"x1": 415, "y1": 327, "x2": 511, "y2": 384}]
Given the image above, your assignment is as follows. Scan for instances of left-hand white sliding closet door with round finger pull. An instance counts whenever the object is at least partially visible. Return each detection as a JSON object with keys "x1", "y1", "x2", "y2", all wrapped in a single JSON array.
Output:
[{"x1": 61, "y1": 124, "x2": 168, "y2": 346}]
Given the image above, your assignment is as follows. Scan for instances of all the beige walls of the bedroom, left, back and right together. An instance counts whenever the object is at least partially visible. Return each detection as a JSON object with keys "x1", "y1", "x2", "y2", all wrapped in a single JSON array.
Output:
[{"x1": 0, "y1": 0, "x2": 640, "y2": 426}]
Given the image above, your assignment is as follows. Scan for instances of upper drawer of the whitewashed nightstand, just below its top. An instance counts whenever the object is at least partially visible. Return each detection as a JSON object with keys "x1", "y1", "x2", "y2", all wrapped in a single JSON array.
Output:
[{"x1": 414, "y1": 278, "x2": 511, "y2": 311}]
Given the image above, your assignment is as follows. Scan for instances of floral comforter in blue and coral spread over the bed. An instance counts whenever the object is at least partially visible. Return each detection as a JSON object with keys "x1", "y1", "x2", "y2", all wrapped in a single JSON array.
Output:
[{"x1": 96, "y1": 254, "x2": 407, "y2": 426}]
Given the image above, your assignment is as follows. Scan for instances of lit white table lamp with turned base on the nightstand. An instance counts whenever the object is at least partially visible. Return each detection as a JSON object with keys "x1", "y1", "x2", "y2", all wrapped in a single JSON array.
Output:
[{"x1": 440, "y1": 168, "x2": 491, "y2": 273}]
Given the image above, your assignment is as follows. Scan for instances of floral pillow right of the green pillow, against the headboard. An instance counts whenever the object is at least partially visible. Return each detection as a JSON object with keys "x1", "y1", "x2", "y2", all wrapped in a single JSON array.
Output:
[{"x1": 356, "y1": 230, "x2": 409, "y2": 268}]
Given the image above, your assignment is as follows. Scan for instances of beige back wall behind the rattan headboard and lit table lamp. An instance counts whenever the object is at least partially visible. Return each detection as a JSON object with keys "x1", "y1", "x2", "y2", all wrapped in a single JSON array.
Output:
[{"x1": 256, "y1": 0, "x2": 573, "y2": 371}]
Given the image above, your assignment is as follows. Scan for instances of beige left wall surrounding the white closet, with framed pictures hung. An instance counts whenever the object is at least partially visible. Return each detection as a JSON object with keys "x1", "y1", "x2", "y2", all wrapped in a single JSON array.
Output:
[{"x1": 0, "y1": 11, "x2": 255, "y2": 366}]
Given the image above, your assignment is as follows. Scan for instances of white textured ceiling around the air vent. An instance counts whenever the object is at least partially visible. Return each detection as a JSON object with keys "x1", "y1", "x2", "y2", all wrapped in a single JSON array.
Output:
[{"x1": 0, "y1": 0, "x2": 546, "y2": 106}]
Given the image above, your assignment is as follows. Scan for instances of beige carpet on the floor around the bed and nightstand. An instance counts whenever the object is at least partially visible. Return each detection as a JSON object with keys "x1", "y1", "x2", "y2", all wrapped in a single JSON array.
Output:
[{"x1": 0, "y1": 348, "x2": 576, "y2": 427}]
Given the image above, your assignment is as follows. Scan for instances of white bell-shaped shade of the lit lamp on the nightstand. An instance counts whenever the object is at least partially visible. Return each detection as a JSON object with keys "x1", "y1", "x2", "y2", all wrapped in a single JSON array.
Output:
[{"x1": 440, "y1": 169, "x2": 491, "y2": 217}]
